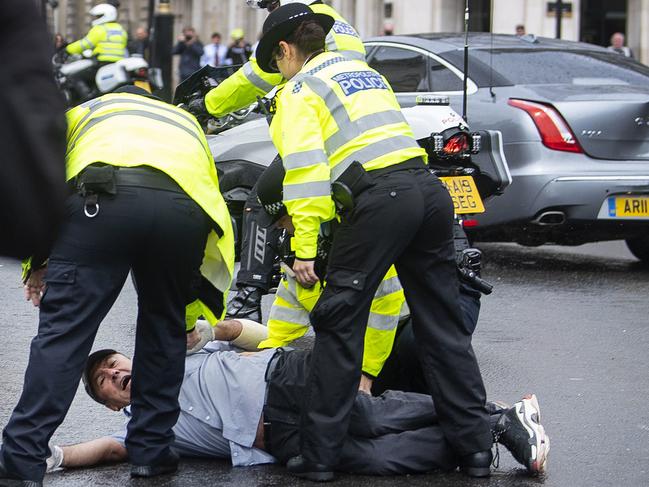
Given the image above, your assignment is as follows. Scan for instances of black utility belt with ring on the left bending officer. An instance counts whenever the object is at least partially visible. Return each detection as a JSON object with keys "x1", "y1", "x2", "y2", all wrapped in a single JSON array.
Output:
[{"x1": 68, "y1": 163, "x2": 185, "y2": 218}]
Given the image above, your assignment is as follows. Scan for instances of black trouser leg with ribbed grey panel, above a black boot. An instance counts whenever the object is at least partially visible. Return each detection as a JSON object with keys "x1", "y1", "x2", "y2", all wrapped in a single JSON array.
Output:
[{"x1": 236, "y1": 184, "x2": 282, "y2": 293}]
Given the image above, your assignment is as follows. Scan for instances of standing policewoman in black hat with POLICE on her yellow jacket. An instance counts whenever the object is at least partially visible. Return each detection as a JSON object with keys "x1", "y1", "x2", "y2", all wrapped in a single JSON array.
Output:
[{"x1": 256, "y1": 4, "x2": 492, "y2": 481}]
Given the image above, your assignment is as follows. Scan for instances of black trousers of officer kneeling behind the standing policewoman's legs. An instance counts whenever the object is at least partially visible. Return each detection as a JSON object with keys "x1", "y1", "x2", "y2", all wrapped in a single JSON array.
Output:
[{"x1": 372, "y1": 282, "x2": 480, "y2": 394}]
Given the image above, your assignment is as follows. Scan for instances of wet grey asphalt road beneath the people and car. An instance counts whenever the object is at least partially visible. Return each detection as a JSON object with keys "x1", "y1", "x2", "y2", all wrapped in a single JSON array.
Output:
[{"x1": 0, "y1": 242, "x2": 649, "y2": 487}]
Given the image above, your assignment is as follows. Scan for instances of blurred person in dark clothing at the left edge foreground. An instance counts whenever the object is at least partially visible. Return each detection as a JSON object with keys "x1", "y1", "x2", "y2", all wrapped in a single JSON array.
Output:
[{"x1": 0, "y1": 0, "x2": 67, "y2": 264}]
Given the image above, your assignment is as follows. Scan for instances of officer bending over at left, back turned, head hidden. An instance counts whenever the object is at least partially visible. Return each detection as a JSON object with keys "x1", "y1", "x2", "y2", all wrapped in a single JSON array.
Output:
[{"x1": 0, "y1": 87, "x2": 234, "y2": 482}]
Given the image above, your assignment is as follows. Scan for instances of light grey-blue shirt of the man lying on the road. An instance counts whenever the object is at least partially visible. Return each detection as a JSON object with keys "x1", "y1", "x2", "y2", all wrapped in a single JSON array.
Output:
[{"x1": 113, "y1": 342, "x2": 275, "y2": 467}]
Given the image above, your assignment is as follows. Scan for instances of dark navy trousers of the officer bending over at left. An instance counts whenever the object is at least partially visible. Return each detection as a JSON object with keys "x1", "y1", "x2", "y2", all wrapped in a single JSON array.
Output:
[{"x1": 2, "y1": 171, "x2": 209, "y2": 480}]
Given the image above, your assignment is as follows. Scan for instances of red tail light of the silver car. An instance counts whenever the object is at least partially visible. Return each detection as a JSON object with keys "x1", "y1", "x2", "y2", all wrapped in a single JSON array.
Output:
[{"x1": 507, "y1": 98, "x2": 583, "y2": 152}]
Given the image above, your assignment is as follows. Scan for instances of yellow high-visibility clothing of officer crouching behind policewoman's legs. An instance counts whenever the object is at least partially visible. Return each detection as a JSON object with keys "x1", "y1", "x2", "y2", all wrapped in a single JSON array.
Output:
[{"x1": 259, "y1": 266, "x2": 406, "y2": 377}]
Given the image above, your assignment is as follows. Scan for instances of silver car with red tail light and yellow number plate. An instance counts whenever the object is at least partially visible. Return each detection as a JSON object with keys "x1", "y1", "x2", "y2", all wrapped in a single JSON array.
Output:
[{"x1": 365, "y1": 34, "x2": 649, "y2": 261}]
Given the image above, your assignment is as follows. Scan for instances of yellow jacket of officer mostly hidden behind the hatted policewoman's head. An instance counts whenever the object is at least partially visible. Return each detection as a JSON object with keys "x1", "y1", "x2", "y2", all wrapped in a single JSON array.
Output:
[{"x1": 205, "y1": 3, "x2": 365, "y2": 117}]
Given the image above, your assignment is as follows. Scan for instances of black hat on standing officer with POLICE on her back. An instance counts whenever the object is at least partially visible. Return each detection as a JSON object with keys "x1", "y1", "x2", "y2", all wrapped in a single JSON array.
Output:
[{"x1": 255, "y1": 3, "x2": 334, "y2": 73}]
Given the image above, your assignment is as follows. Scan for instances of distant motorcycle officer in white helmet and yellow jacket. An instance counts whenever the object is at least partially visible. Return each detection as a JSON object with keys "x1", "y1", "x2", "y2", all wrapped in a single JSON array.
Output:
[{"x1": 65, "y1": 3, "x2": 128, "y2": 63}]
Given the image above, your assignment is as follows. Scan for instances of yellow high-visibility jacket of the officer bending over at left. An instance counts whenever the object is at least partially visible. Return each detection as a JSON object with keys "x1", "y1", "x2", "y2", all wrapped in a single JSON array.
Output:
[{"x1": 66, "y1": 93, "x2": 234, "y2": 329}]
